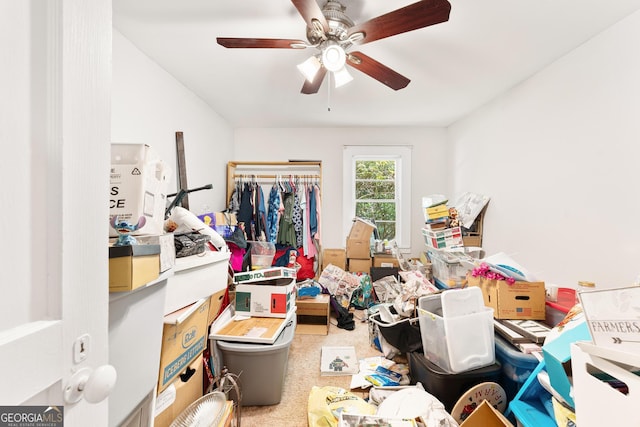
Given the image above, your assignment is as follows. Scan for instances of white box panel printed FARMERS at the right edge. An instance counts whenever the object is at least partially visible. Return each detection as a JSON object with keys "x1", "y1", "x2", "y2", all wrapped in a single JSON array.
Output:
[{"x1": 578, "y1": 286, "x2": 640, "y2": 354}]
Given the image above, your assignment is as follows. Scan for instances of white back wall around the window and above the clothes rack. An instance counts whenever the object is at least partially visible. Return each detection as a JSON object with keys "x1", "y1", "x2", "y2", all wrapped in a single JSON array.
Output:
[{"x1": 234, "y1": 128, "x2": 447, "y2": 256}]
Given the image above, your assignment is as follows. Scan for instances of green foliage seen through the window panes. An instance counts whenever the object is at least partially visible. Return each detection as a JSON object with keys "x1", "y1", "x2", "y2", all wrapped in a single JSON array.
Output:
[{"x1": 355, "y1": 160, "x2": 396, "y2": 240}]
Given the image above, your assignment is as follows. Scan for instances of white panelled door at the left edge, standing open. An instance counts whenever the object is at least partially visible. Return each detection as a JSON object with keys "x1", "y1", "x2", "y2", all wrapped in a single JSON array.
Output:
[{"x1": 0, "y1": 0, "x2": 111, "y2": 427}]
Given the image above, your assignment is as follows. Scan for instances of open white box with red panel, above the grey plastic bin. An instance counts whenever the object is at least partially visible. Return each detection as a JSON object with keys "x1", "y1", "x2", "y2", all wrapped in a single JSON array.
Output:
[{"x1": 235, "y1": 279, "x2": 296, "y2": 317}]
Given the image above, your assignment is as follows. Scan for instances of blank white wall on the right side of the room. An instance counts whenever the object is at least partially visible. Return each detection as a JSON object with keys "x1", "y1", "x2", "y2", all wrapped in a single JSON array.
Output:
[{"x1": 448, "y1": 13, "x2": 640, "y2": 287}]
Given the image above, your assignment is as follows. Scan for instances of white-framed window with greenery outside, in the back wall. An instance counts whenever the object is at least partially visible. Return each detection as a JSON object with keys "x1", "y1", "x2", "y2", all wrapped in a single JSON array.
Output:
[{"x1": 343, "y1": 146, "x2": 411, "y2": 248}]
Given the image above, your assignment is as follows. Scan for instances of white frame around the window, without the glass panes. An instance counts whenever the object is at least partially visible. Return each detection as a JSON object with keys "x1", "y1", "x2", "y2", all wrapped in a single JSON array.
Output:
[{"x1": 342, "y1": 145, "x2": 412, "y2": 250}]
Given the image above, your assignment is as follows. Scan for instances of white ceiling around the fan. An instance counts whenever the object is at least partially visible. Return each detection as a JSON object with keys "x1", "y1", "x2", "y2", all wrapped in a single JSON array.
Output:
[{"x1": 113, "y1": 0, "x2": 640, "y2": 127}]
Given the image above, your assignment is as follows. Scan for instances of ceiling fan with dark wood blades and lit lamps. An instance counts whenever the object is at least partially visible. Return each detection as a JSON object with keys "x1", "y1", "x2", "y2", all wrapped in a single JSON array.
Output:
[{"x1": 217, "y1": 0, "x2": 451, "y2": 94}]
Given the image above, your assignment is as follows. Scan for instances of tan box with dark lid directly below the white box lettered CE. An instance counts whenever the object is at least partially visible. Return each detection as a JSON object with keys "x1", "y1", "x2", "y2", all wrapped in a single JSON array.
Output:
[{"x1": 109, "y1": 245, "x2": 160, "y2": 292}]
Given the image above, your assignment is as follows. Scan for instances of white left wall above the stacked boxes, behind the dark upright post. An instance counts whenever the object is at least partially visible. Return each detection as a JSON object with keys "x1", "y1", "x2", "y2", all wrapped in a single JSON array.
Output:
[{"x1": 111, "y1": 28, "x2": 233, "y2": 214}]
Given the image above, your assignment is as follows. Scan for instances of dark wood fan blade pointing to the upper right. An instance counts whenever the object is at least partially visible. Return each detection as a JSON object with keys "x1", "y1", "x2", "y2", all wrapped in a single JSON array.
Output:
[{"x1": 349, "y1": 0, "x2": 451, "y2": 44}]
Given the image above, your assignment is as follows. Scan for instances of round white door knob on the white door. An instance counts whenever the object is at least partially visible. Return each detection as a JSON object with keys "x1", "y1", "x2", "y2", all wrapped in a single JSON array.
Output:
[{"x1": 64, "y1": 365, "x2": 117, "y2": 403}]
